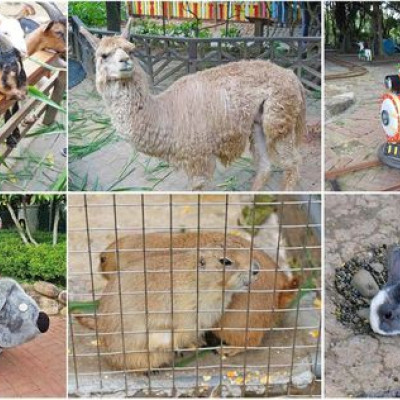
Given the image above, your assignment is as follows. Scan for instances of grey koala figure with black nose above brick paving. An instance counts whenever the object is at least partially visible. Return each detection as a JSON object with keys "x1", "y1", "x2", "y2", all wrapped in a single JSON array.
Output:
[{"x1": 0, "y1": 278, "x2": 50, "y2": 352}]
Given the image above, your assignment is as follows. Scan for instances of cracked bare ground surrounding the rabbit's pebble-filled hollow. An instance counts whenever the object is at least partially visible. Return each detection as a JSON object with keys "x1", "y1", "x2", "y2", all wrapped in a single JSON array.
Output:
[{"x1": 325, "y1": 195, "x2": 400, "y2": 398}]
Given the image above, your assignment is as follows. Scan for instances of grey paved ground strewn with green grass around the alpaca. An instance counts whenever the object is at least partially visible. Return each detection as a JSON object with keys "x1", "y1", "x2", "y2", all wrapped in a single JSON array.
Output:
[{"x1": 69, "y1": 73, "x2": 321, "y2": 191}]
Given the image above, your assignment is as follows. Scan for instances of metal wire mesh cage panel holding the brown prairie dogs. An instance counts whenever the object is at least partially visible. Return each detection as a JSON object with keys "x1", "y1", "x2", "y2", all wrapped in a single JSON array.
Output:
[{"x1": 69, "y1": 194, "x2": 321, "y2": 397}]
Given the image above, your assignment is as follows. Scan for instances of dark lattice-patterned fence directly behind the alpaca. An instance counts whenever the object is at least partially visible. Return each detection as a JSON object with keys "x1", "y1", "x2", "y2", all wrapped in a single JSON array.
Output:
[{"x1": 70, "y1": 16, "x2": 321, "y2": 90}]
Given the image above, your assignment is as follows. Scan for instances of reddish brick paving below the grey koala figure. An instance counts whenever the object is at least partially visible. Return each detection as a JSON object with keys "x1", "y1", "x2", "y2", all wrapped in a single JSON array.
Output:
[{"x1": 0, "y1": 317, "x2": 66, "y2": 398}]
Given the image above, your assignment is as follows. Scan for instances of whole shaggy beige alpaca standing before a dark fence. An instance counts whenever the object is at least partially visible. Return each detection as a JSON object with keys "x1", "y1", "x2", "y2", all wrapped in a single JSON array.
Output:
[{"x1": 81, "y1": 20, "x2": 307, "y2": 190}]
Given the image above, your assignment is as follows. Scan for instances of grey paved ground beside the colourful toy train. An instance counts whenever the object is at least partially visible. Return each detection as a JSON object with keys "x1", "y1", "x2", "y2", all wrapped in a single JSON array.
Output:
[{"x1": 325, "y1": 55, "x2": 400, "y2": 191}]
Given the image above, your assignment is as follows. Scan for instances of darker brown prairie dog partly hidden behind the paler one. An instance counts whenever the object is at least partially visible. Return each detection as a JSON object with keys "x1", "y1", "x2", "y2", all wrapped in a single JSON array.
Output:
[{"x1": 100, "y1": 232, "x2": 297, "y2": 356}]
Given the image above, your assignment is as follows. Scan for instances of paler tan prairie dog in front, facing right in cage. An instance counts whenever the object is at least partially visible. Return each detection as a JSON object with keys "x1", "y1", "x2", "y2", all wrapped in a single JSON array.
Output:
[{"x1": 85, "y1": 234, "x2": 259, "y2": 371}]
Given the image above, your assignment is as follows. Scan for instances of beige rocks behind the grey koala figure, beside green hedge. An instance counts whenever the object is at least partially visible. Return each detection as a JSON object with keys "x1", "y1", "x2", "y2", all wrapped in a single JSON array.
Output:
[{"x1": 22, "y1": 281, "x2": 67, "y2": 316}]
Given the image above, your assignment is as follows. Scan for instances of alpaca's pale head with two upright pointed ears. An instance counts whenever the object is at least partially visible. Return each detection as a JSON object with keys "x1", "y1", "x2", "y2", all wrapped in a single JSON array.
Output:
[{"x1": 81, "y1": 19, "x2": 135, "y2": 88}]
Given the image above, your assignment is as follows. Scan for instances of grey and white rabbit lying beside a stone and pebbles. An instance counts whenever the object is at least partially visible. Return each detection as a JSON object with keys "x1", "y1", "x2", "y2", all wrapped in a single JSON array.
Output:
[{"x1": 369, "y1": 245, "x2": 400, "y2": 336}]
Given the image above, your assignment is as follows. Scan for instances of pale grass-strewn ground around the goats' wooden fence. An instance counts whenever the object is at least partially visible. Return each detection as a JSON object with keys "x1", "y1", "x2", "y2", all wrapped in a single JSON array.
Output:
[{"x1": 0, "y1": 1, "x2": 68, "y2": 191}]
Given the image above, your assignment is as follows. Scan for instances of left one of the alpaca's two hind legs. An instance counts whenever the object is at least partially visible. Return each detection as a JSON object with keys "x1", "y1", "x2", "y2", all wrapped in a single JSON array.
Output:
[{"x1": 250, "y1": 122, "x2": 271, "y2": 190}]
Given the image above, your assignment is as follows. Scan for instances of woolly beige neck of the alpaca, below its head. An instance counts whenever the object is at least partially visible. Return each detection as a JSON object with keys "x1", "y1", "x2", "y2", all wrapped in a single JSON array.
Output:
[{"x1": 98, "y1": 71, "x2": 166, "y2": 157}]
